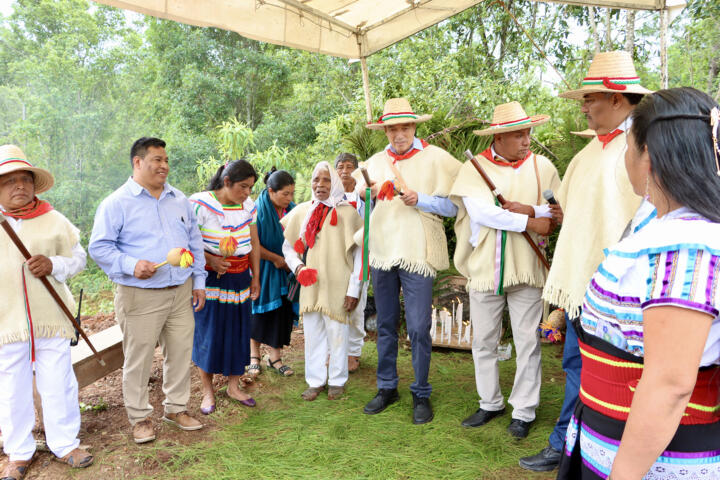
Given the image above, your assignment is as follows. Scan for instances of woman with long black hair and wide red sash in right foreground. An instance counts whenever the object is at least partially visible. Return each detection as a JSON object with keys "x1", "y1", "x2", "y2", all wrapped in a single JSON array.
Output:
[{"x1": 558, "y1": 88, "x2": 720, "y2": 480}]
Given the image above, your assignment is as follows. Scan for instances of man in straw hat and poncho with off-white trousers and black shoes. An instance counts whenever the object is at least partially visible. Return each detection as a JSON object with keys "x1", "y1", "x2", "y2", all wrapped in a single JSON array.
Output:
[{"x1": 451, "y1": 102, "x2": 560, "y2": 438}]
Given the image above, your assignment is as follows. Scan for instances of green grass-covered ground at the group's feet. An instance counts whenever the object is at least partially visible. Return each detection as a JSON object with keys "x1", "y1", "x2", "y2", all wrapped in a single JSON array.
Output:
[{"x1": 156, "y1": 342, "x2": 563, "y2": 479}]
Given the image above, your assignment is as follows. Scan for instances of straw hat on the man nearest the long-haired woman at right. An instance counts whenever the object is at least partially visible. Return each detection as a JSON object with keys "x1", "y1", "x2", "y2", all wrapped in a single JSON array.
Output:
[{"x1": 559, "y1": 51, "x2": 652, "y2": 100}]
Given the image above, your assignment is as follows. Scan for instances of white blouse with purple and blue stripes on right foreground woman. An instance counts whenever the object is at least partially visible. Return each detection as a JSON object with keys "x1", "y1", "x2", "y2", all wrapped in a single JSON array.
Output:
[{"x1": 581, "y1": 208, "x2": 720, "y2": 366}]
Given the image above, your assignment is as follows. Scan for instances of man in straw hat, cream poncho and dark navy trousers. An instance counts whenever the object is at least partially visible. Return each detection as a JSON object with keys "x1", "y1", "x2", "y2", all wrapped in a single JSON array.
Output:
[{"x1": 354, "y1": 98, "x2": 461, "y2": 424}]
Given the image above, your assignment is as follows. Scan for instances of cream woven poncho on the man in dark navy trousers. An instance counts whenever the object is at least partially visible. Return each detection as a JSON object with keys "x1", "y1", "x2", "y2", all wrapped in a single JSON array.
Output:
[{"x1": 353, "y1": 145, "x2": 464, "y2": 277}]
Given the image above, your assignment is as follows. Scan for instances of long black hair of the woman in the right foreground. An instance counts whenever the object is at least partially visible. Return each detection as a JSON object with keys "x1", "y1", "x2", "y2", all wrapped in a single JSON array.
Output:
[{"x1": 630, "y1": 87, "x2": 720, "y2": 222}]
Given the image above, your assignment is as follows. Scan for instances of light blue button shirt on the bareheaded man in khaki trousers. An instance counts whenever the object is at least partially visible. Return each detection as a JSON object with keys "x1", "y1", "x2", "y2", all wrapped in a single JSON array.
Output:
[{"x1": 88, "y1": 177, "x2": 207, "y2": 290}]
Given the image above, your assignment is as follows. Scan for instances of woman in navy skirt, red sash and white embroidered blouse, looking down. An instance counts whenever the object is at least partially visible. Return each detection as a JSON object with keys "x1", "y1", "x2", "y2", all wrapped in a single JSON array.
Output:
[{"x1": 190, "y1": 160, "x2": 260, "y2": 415}]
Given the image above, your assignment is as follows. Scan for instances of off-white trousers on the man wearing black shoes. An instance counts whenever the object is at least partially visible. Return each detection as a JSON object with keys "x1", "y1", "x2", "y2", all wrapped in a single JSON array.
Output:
[{"x1": 470, "y1": 285, "x2": 542, "y2": 422}]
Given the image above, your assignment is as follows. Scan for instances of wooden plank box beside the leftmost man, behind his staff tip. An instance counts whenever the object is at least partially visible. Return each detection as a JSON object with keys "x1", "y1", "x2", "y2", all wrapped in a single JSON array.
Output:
[{"x1": 70, "y1": 325, "x2": 125, "y2": 388}]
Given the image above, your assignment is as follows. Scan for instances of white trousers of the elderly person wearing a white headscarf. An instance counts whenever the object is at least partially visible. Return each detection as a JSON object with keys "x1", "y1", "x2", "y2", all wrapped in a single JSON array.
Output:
[{"x1": 303, "y1": 312, "x2": 348, "y2": 387}]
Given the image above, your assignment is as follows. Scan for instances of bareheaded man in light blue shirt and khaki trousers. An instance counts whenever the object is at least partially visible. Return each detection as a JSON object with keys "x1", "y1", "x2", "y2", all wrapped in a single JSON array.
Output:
[{"x1": 88, "y1": 137, "x2": 207, "y2": 443}]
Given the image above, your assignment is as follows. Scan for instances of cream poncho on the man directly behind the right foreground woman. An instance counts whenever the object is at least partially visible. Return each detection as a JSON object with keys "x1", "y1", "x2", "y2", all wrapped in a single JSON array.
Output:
[{"x1": 543, "y1": 133, "x2": 642, "y2": 318}]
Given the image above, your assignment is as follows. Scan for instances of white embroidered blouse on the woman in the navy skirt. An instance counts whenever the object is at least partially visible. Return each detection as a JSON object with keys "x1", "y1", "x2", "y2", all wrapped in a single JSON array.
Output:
[{"x1": 190, "y1": 191, "x2": 257, "y2": 257}]
